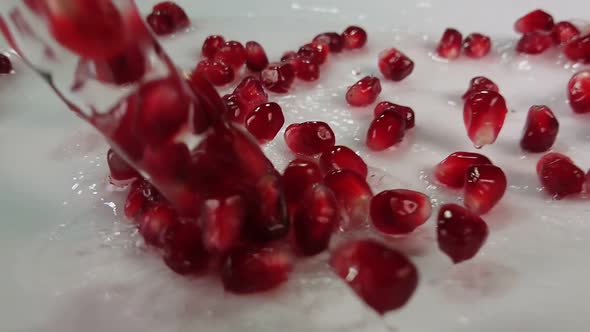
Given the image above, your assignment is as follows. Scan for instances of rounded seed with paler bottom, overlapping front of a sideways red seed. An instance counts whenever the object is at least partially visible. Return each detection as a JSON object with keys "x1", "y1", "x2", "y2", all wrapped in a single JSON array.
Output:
[{"x1": 465, "y1": 165, "x2": 507, "y2": 215}]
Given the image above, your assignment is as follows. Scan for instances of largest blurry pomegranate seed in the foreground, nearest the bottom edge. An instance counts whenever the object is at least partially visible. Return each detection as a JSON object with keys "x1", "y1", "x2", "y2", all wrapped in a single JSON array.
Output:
[{"x1": 330, "y1": 240, "x2": 418, "y2": 315}]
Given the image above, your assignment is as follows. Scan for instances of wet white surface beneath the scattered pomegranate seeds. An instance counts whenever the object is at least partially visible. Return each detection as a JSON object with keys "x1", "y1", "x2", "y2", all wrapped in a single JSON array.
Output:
[{"x1": 0, "y1": 0, "x2": 590, "y2": 332}]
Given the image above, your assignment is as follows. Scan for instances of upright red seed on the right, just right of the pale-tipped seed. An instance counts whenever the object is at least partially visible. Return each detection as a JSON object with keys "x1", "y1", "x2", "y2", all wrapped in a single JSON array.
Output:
[{"x1": 520, "y1": 105, "x2": 559, "y2": 152}]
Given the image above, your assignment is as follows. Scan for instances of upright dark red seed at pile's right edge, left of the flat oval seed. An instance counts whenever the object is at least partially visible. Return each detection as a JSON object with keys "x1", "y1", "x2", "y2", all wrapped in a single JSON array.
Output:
[{"x1": 293, "y1": 184, "x2": 340, "y2": 256}]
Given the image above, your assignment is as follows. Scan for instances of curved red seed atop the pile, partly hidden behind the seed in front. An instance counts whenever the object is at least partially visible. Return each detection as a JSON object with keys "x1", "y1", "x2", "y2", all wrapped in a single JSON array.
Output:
[{"x1": 320, "y1": 145, "x2": 368, "y2": 179}]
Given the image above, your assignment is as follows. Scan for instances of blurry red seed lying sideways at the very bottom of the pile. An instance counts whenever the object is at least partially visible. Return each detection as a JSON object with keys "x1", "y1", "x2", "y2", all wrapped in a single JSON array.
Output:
[{"x1": 221, "y1": 248, "x2": 293, "y2": 294}]
